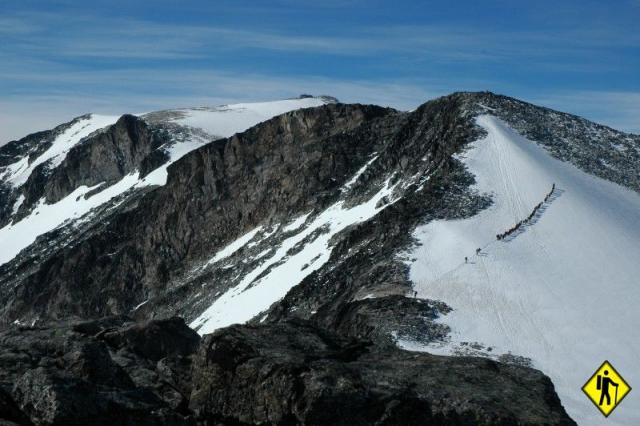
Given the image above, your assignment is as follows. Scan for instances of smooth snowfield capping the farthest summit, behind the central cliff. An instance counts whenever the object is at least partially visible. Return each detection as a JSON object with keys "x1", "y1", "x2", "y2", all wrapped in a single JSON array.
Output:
[{"x1": 142, "y1": 95, "x2": 337, "y2": 138}]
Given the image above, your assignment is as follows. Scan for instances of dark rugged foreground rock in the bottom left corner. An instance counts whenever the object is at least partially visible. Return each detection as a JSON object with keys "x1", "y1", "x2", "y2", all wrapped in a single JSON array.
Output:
[{"x1": 0, "y1": 317, "x2": 200, "y2": 426}]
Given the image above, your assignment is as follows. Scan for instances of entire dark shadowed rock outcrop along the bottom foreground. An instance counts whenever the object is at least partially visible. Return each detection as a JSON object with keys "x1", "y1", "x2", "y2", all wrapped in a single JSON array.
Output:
[{"x1": 0, "y1": 317, "x2": 574, "y2": 426}]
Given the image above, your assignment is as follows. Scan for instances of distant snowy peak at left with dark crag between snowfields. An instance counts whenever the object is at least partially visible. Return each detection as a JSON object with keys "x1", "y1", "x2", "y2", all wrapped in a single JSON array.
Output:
[{"x1": 0, "y1": 96, "x2": 335, "y2": 265}]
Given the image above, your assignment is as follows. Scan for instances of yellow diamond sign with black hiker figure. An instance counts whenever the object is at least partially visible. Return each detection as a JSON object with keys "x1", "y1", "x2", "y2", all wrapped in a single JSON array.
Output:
[{"x1": 582, "y1": 361, "x2": 631, "y2": 417}]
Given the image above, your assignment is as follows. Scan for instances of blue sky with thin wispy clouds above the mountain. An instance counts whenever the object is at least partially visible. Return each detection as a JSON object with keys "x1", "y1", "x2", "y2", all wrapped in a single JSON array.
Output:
[{"x1": 0, "y1": 0, "x2": 640, "y2": 143}]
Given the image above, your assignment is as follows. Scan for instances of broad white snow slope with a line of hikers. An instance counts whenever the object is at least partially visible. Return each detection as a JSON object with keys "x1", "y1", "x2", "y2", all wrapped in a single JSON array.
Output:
[{"x1": 408, "y1": 115, "x2": 640, "y2": 425}]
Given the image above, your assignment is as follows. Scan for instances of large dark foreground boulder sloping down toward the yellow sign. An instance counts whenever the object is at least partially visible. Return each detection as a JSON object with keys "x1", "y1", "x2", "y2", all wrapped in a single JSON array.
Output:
[{"x1": 190, "y1": 321, "x2": 574, "y2": 425}]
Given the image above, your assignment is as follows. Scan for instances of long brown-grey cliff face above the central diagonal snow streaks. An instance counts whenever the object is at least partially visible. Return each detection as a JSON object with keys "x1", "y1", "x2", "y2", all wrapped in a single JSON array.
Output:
[{"x1": 0, "y1": 105, "x2": 396, "y2": 319}]
